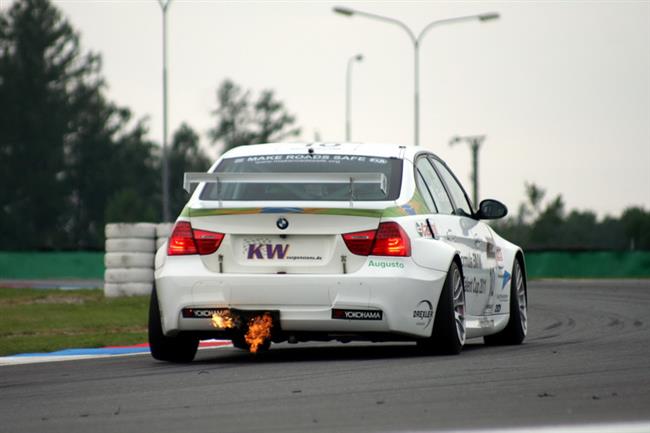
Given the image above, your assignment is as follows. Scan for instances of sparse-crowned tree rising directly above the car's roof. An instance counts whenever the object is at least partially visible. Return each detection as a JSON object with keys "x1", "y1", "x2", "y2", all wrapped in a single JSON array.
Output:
[{"x1": 209, "y1": 79, "x2": 300, "y2": 152}]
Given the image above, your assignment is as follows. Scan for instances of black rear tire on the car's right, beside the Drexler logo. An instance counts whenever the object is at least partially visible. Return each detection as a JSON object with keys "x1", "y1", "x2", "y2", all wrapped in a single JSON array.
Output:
[{"x1": 417, "y1": 261, "x2": 466, "y2": 355}]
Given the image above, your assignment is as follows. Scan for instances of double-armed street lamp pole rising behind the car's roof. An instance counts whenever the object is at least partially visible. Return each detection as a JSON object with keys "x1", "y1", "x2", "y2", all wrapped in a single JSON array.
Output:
[{"x1": 333, "y1": 7, "x2": 499, "y2": 146}]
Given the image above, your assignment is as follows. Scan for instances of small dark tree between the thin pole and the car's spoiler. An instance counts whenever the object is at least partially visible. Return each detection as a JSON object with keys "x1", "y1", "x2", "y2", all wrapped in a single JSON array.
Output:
[{"x1": 168, "y1": 123, "x2": 210, "y2": 215}]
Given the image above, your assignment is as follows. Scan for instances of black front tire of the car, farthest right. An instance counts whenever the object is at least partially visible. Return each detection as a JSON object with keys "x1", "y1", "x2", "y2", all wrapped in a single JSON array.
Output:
[{"x1": 483, "y1": 259, "x2": 528, "y2": 346}]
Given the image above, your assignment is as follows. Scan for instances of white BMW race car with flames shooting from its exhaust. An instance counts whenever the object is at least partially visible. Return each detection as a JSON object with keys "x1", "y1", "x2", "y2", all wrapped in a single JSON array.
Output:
[{"x1": 149, "y1": 143, "x2": 527, "y2": 362}]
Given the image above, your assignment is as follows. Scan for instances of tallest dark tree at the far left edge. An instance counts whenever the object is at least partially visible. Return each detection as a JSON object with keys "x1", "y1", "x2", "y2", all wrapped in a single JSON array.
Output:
[{"x1": 0, "y1": 0, "x2": 77, "y2": 247}]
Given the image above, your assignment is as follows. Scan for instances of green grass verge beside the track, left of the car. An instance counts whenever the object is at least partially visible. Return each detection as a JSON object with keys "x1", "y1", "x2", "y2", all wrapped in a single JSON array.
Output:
[{"x1": 0, "y1": 288, "x2": 149, "y2": 356}]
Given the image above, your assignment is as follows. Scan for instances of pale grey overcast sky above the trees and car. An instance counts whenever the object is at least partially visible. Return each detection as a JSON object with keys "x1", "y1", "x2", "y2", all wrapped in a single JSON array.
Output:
[{"x1": 0, "y1": 0, "x2": 650, "y2": 216}]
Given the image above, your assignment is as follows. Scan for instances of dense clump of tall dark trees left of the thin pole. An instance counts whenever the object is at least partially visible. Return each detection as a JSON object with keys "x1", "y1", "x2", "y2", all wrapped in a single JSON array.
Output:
[{"x1": 0, "y1": 0, "x2": 158, "y2": 249}]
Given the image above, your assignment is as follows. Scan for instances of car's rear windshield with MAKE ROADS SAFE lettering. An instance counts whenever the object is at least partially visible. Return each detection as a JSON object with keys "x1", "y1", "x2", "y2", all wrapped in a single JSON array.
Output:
[{"x1": 200, "y1": 154, "x2": 402, "y2": 201}]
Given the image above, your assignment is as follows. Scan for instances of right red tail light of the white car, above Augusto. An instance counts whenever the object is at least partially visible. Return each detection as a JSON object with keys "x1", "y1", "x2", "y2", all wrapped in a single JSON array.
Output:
[{"x1": 343, "y1": 222, "x2": 411, "y2": 257}]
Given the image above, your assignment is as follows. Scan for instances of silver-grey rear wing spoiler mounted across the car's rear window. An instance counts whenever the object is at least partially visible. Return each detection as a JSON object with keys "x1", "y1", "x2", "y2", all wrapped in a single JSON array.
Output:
[{"x1": 183, "y1": 173, "x2": 388, "y2": 207}]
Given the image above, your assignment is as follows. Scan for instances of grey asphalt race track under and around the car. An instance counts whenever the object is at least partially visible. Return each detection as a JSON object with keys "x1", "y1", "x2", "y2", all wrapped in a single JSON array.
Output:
[{"x1": 0, "y1": 280, "x2": 650, "y2": 433}]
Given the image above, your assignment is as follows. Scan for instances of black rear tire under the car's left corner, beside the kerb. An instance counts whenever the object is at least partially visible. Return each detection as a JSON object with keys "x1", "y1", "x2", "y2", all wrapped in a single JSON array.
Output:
[{"x1": 149, "y1": 287, "x2": 199, "y2": 363}]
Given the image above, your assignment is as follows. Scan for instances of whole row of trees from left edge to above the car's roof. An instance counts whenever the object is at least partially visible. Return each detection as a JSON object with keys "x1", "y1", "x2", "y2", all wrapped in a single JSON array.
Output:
[{"x1": 0, "y1": 0, "x2": 299, "y2": 250}]
